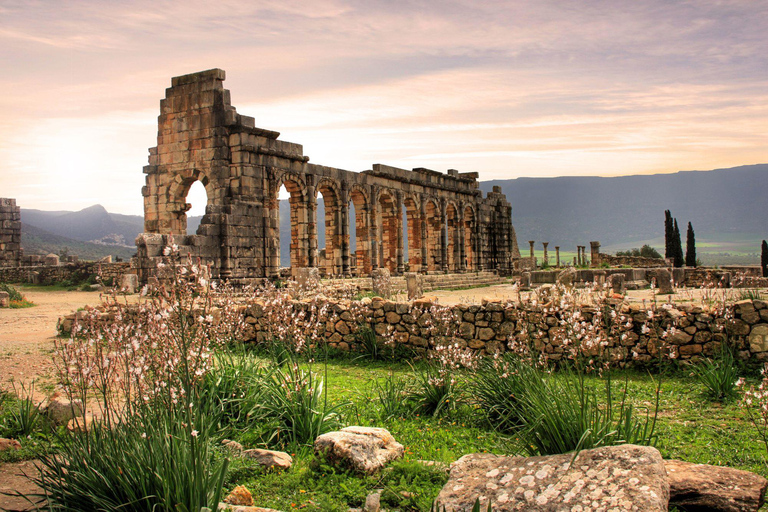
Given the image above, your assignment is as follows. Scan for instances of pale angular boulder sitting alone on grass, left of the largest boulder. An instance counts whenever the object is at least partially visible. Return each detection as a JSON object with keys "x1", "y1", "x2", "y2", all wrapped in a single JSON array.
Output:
[{"x1": 315, "y1": 427, "x2": 405, "y2": 474}]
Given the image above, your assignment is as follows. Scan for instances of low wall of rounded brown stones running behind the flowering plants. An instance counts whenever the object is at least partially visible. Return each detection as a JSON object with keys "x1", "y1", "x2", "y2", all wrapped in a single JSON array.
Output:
[{"x1": 240, "y1": 298, "x2": 768, "y2": 364}]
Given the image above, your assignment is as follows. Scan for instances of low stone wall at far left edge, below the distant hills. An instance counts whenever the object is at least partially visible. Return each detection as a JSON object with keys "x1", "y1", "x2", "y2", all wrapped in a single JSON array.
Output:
[{"x1": 0, "y1": 262, "x2": 134, "y2": 284}]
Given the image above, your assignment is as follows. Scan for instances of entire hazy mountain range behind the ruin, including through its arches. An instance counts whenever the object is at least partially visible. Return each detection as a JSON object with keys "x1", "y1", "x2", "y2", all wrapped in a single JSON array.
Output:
[{"x1": 21, "y1": 164, "x2": 768, "y2": 266}]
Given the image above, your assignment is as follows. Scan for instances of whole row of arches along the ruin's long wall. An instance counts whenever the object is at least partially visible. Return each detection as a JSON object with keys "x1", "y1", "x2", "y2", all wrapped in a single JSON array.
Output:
[{"x1": 267, "y1": 173, "x2": 482, "y2": 275}]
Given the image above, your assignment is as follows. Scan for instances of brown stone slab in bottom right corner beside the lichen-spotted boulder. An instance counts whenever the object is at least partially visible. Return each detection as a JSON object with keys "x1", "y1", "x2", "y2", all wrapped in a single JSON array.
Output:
[{"x1": 664, "y1": 460, "x2": 768, "y2": 512}]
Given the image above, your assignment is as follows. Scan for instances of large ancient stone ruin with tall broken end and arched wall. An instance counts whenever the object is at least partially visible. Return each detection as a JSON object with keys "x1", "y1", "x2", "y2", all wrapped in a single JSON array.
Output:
[{"x1": 134, "y1": 69, "x2": 519, "y2": 282}]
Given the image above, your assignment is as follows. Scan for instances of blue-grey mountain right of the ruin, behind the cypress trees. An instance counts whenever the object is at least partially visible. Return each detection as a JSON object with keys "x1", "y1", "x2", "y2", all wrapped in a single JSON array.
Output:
[{"x1": 480, "y1": 164, "x2": 768, "y2": 263}]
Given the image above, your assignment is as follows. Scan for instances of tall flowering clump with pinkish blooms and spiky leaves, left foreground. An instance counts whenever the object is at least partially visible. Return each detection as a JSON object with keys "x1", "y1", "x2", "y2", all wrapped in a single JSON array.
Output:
[{"x1": 35, "y1": 246, "x2": 242, "y2": 512}]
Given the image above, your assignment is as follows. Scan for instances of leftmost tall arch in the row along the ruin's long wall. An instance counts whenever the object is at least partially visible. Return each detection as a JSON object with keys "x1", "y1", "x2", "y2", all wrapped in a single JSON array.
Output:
[{"x1": 270, "y1": 172, "x2": 311, "y2": 276}]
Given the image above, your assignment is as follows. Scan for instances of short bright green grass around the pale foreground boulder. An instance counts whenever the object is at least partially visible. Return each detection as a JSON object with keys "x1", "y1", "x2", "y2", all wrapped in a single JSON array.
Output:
[{"x1": 212, "y1": 359, "x2": 768, "y2": 511}]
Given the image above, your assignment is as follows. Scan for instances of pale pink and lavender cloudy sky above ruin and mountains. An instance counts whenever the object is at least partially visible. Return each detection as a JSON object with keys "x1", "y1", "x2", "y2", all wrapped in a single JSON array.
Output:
[{"x1": 0, "y1": 0, "x2": 768, "y2": 214}]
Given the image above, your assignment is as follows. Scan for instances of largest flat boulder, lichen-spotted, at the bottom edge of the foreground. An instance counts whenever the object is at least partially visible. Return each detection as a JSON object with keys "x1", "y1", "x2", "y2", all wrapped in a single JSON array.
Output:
[{"x1": 437, "y1": 445, "x2": 669, "y2": 512}]
